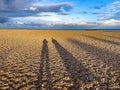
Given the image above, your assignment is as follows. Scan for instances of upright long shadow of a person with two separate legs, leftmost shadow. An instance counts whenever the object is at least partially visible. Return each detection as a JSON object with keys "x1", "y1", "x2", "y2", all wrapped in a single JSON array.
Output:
[{"x1": 37, "y1": 39, "x2": 52, "y2": 90}]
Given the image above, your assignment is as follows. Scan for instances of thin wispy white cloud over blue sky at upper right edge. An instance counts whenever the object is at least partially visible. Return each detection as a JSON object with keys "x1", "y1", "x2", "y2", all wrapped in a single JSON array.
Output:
[{"x1": 94, "y1": 1, "x2": 120, "y2": 20}]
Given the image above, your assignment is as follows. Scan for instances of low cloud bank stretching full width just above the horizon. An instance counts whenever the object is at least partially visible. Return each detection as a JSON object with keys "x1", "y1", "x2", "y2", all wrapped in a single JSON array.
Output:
[{"x1": 0, "y1": 17, "x2": 120, "y2": 30}]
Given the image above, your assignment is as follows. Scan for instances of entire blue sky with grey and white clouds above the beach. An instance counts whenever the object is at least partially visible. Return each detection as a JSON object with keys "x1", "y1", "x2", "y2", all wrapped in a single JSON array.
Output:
[{"x1": 0, "y1": 0, "x2": 120, "y2": 29}]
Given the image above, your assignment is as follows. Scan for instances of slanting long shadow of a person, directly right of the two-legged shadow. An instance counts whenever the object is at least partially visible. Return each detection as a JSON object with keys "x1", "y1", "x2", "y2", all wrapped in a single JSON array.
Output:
[{"x1": 52, "y1": 39, "x2": 95, "y2": 90}]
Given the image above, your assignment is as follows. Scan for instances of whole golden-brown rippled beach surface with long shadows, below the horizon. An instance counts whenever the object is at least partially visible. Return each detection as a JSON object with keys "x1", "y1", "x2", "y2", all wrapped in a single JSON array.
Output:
[{"x1": 0, "y1": 30, "x2": 120, "y2": 90}]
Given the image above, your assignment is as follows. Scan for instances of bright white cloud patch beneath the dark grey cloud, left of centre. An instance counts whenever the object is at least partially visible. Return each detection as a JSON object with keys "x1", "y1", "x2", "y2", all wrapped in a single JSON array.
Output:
[{"x1": 11, "y1": 13, "x2": 61, "y2": 24}]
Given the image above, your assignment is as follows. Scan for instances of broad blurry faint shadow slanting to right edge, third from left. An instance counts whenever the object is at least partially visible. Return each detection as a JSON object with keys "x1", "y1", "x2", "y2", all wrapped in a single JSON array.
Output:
[{"x1": 67, "y1": 38, "x2": 120, "y2": 70}]
